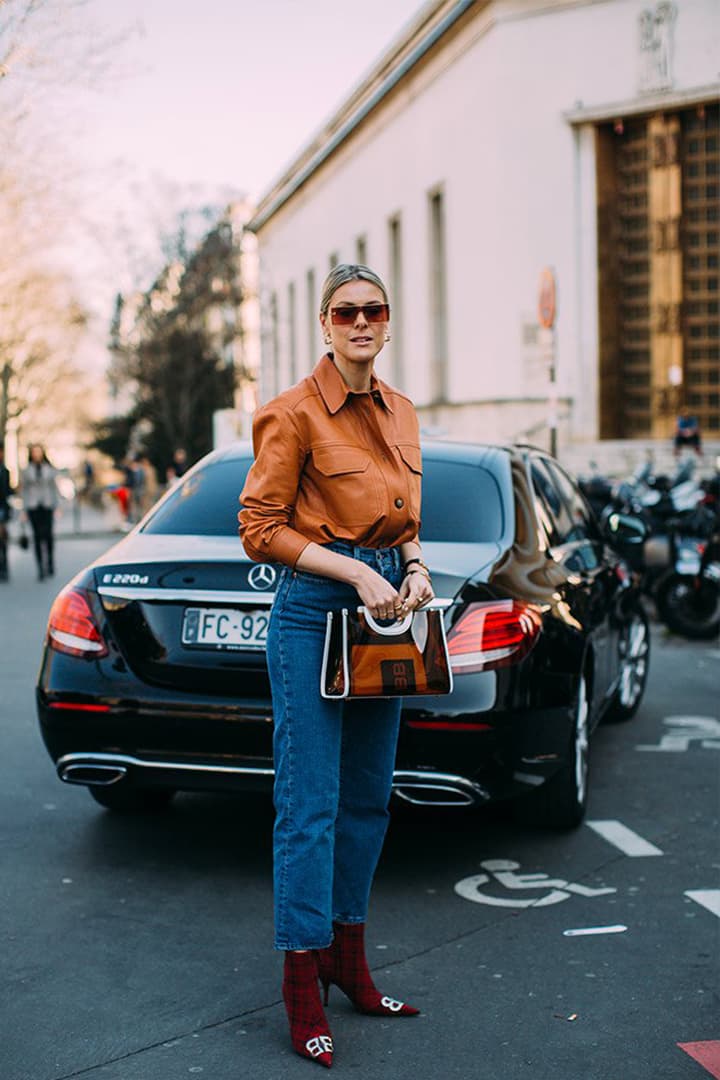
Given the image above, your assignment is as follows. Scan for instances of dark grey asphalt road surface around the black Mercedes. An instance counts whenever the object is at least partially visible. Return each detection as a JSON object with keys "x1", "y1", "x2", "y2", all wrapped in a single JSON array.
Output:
[{"x1": 0, "y1": 539, "x2": 720, "y2": 1080}]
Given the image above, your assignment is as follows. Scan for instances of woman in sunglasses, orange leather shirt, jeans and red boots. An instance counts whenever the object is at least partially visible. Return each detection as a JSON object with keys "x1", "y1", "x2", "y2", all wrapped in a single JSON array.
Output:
[{"x1": 239, "y1": 265, "x2": 433, "y2": 1067}]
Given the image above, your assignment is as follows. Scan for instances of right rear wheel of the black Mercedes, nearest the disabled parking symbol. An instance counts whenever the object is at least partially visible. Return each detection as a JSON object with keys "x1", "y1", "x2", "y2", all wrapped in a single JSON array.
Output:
[{"x1": 516, "y1": 673, "x2": 590, "y2": 829}]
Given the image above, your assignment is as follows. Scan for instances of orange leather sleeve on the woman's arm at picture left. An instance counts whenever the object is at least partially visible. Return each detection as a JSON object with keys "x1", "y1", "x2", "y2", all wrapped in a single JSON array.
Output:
[{"x1": 237, "y1": 402, "x2": 310, "y2": 566}]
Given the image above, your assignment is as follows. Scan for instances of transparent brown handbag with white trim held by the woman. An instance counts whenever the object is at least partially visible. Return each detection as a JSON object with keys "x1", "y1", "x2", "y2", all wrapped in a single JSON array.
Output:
[{"x1": 321, "y1": 607, "x2": 452, "y2": 699}]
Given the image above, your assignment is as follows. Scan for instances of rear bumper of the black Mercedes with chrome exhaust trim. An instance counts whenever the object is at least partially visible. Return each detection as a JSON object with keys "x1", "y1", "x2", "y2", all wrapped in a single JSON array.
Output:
[{"x1": 37, "y1": 673, "x2": 572, "y2": 807}]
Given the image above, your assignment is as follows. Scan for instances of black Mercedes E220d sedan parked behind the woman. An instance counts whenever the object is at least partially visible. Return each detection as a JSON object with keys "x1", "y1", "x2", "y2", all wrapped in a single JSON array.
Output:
[{"x1": 37, "y1": 442, "x2": 650, "y2": 827}]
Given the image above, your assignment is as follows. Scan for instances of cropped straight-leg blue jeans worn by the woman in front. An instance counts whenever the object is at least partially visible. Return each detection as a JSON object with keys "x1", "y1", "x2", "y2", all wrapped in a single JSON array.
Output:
[{"x1": 268, "y1": 541, "x2": 403, "y2": 949}]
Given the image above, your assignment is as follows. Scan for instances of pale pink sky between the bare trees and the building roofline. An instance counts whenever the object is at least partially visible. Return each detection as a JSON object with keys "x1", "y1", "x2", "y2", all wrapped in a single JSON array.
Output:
[{"x1": 77, "y1": 0, "x2": 425, "y2": 195}]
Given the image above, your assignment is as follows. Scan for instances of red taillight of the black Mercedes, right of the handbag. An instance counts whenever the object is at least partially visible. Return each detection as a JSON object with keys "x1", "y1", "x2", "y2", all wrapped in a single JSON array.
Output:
[{"x1": 448, "y1": 600, "x2": 542, "y2": 675}]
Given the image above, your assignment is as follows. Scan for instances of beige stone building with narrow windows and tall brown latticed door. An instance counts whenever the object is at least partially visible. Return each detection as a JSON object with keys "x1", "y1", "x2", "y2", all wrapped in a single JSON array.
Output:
[{"x1": 250, "y1": 0, "x2": 720, "y2": 470}]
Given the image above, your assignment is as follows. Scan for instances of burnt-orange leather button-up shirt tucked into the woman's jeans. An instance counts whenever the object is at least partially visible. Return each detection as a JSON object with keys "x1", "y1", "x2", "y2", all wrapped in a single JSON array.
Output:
[{"x1": 237, "y1": 354, "x2": 422, "y2": 566}]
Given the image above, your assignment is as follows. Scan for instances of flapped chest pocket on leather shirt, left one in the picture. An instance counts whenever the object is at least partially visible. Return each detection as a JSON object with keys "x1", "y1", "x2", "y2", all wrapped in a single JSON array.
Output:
[{"x1": 312, "y1": 446, "x2": 380, "y2": 526}]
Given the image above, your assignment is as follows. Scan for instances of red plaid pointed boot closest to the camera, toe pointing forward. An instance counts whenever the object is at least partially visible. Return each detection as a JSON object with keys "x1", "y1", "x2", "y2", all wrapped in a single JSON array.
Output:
[{"x1": 283, "y1": 953, "x2": 332, "y2": 1069}]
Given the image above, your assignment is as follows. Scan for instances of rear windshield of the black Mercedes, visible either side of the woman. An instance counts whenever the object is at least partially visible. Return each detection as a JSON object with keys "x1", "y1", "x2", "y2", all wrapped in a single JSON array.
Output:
[{"x1": 142, "y1": 458, "x2": 505, "y2": 543}]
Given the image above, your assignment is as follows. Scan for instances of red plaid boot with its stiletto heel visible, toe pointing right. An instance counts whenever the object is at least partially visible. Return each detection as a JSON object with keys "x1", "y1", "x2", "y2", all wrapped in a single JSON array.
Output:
[{"x1": 317, "y1": 922, "x2": 420, "y2": 1016}]
